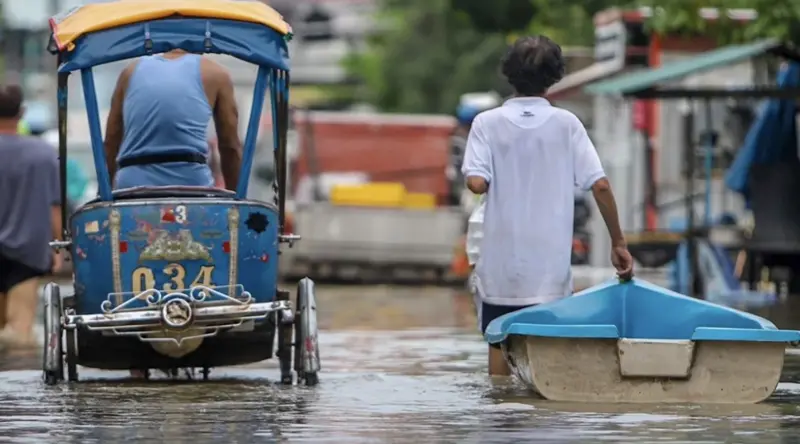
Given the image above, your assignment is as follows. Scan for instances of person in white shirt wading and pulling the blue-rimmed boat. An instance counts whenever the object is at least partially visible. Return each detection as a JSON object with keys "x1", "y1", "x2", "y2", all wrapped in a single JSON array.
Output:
[{"x1": 462, "y1": 36, "x2": 633, "y2": 375}]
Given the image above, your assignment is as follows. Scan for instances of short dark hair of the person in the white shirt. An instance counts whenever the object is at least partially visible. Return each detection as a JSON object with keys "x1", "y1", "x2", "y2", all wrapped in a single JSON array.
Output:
[{"x1": 502, "y1": 35, "x2": 565, "y2": 96}]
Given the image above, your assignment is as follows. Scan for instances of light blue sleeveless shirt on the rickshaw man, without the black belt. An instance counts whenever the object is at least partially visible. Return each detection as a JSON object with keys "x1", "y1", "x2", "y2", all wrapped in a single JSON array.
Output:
[{"x1": 114, "y1": 54, "x2": 214, "y2": 189}]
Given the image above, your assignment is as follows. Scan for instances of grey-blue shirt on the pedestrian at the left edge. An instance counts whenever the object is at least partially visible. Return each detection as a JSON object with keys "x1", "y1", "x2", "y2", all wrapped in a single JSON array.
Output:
[{"x1": 0, "y1": 135, "x2": 60, "y2": 271}]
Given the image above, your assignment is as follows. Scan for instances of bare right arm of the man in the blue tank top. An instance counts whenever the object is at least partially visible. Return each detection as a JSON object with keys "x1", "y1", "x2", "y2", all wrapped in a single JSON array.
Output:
[{"x1": 208, "y1": 62, "x2": 242, "y2": 191}]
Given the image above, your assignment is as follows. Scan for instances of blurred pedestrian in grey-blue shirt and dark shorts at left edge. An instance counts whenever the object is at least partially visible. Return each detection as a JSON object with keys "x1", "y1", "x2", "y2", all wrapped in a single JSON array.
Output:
[{"x1": 0, "y1": 84, "x2": 62, "y2": 347}]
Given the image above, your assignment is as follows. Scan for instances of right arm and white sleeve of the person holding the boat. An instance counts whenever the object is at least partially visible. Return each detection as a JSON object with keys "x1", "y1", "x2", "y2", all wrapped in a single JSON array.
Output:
[{"x1": 572, "y1": 122, "x2": 633, "y2": 277}]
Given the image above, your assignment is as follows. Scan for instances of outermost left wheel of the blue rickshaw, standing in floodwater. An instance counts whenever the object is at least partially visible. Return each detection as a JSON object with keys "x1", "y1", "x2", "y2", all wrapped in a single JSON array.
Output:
[{"x1": 42, "y1": 282, "x2": 64, "y2": 385}]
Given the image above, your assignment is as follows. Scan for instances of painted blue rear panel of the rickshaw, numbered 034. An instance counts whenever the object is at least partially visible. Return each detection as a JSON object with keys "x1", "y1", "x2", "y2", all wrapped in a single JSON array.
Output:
[{"x1": 70, "y1": 199, "x2": 278, "y2": 314}]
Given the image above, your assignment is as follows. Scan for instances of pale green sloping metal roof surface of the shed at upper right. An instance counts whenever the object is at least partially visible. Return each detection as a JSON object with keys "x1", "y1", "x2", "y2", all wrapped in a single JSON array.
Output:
[{"x1": 584, "y1": 39, "x2": 780, "y2": 95}]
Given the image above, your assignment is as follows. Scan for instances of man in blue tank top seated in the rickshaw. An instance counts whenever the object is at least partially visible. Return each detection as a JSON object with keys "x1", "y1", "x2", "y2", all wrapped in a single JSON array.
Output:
[{"x1": 105, "y1": 50, "x2": 242, "y2": 189}]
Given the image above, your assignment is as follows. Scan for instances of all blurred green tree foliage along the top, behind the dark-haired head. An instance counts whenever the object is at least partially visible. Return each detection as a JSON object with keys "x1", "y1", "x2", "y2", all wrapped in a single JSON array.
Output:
[{"x1": 346, "y1": 0, "x2": 800, "y2": 113}]
